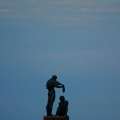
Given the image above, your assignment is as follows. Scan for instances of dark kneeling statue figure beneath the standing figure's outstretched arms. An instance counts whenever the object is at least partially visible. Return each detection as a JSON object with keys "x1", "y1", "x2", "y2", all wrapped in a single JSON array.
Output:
[{"x1": 56, "y1": 96, "x2": 68, "y2": 116}]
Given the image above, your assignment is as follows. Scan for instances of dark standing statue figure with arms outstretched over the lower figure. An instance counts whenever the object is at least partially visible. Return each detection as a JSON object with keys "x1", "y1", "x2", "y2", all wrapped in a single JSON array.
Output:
[{"x1": 46, "y1": 75, "x2": 65, "y2": 116}]
